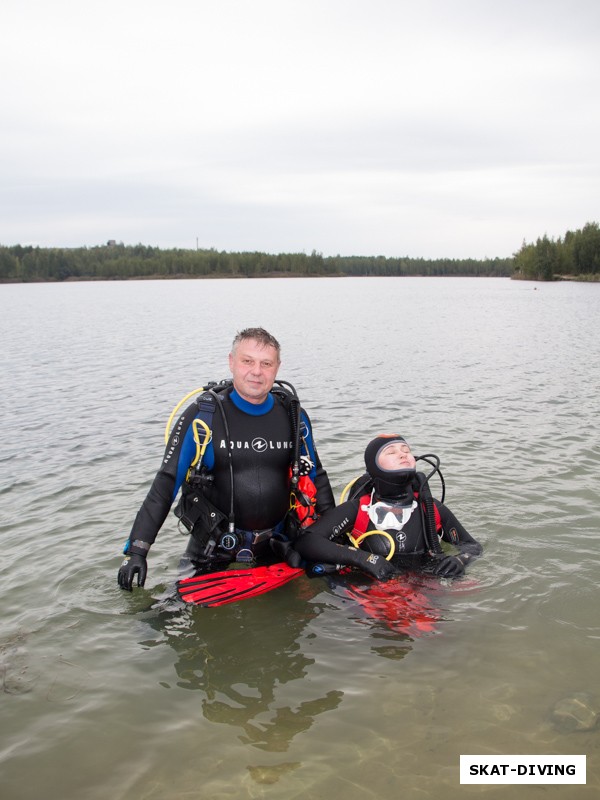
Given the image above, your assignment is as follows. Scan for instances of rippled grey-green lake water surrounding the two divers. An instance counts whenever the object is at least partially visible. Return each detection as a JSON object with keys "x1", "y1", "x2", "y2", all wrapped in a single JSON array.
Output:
[{"x1": 0, "y1": 278, "x2": 600, "y2": 800}]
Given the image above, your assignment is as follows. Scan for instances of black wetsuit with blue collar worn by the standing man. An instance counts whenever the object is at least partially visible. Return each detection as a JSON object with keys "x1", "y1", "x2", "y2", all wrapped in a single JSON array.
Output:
[{"x1": 127, "y1": 389, "x2": 334, "y2": 558}]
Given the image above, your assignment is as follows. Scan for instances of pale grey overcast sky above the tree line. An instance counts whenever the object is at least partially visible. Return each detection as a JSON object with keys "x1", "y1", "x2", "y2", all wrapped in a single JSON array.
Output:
[{"x1": 0, "y1": 0, "x2": 600, "y2": 258}]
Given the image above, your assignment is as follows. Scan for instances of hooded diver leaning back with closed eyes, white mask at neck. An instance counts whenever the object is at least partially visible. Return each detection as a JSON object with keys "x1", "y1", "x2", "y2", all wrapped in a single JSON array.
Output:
[{"x1": 294, "y1": 434, "x2": 482, "y2": 579}]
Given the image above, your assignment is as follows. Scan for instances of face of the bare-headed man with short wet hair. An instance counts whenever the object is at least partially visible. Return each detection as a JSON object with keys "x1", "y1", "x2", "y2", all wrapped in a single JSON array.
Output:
[{"x1": 229, "y1": 339, "x2": 279, "y2": 404}]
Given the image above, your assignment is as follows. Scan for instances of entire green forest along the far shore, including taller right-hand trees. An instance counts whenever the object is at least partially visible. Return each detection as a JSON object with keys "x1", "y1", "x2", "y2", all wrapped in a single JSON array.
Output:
[{"x1": 0, "y1": 223, "x2": 600, "y2": 283}]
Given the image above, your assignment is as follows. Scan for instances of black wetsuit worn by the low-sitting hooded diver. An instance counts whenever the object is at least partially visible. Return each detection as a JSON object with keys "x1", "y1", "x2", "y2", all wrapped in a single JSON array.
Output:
[{"x1": 294, "y1": 484, "x2": 482, "y2": 568}]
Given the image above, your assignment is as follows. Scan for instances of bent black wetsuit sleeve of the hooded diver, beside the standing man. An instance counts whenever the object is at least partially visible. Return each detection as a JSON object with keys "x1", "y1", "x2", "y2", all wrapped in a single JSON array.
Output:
[{"x1": 294, "y1": 500, "x2": 367, "y2": 567}]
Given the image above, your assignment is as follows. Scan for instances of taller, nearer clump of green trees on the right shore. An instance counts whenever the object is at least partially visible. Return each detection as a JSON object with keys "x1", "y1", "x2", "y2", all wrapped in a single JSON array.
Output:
[{"x1": 514, "y1": 222, "x2": 600, "y2": 281}]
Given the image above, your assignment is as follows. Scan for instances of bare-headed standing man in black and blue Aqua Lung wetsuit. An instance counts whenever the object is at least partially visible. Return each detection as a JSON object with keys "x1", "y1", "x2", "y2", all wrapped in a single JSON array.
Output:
[{"x1": 118, "y1": 328, "x2": 334, "y2": 591}]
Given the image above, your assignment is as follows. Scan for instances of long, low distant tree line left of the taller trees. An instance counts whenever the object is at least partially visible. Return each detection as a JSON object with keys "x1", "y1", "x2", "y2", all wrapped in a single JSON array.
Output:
[{"x1": 0, "y1": 242, "x2": 513, "y2": 283}]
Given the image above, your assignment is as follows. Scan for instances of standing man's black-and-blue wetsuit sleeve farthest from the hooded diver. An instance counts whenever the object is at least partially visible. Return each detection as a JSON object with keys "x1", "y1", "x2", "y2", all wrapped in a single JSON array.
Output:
[{"x1": 127, "y1": 403, "x2": 198, "y2": 555}]
